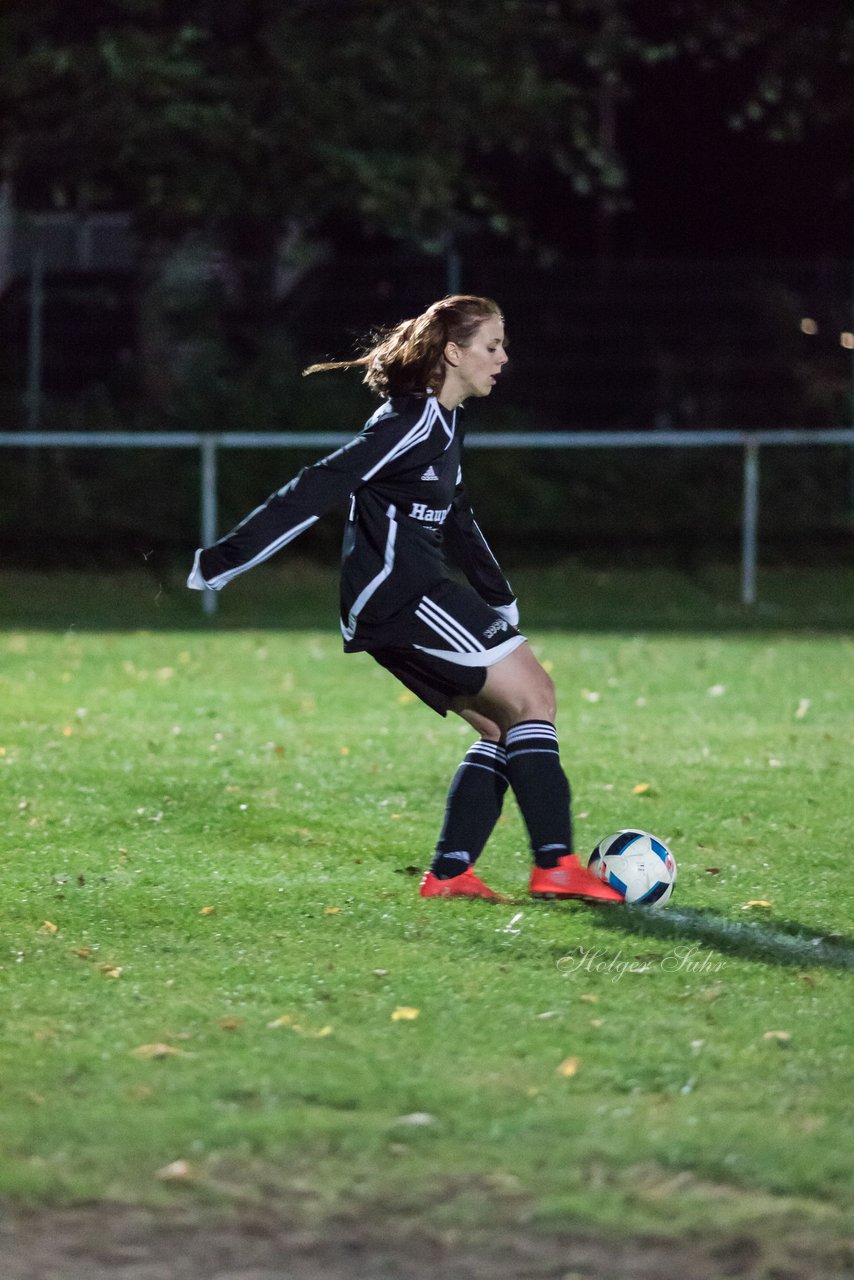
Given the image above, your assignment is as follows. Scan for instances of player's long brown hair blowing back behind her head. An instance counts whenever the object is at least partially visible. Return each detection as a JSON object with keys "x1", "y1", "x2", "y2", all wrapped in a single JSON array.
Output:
[{"x1": 303, "y1": 293, "x2": 503, "y2": 397}]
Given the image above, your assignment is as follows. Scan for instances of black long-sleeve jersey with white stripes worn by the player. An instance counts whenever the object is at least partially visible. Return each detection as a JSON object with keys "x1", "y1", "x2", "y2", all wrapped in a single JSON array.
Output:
[{"x1": 189, "y1": 396, "x2": 513, "y2": 652}]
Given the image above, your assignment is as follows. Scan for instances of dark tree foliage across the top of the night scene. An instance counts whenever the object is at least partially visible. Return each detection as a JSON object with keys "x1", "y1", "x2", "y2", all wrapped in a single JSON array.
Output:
[{"x1": 0, "y1": 0, "x2": 854, "y2": 248}]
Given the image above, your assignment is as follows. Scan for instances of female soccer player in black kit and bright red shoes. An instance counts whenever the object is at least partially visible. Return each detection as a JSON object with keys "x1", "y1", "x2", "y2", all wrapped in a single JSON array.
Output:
[{"x1": 187, "y1": 296, "x2": 621, "y2": 901}]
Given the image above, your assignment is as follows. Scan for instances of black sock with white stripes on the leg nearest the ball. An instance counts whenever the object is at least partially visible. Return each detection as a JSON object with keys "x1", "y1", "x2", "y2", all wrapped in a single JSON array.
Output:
[{"x1": 507, "y1": 721, "x2": 572, "y2": 867}]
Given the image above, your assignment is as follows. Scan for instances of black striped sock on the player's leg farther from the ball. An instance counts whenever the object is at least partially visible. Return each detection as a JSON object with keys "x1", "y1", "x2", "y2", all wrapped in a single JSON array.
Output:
[{"x1": 430, "y1": 740, "x2": 507, "y2": 879}]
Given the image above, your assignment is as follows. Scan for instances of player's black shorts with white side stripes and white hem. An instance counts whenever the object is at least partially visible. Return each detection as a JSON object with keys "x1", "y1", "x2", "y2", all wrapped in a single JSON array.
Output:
[{"x1": 367, "y1": 582, "x2": 525, "y2": 716}]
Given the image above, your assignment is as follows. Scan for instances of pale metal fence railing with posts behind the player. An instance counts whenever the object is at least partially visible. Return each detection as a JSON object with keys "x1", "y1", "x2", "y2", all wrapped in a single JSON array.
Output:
[{"x1": 0, "y1": 428, "x2": 854, "y2": 613}]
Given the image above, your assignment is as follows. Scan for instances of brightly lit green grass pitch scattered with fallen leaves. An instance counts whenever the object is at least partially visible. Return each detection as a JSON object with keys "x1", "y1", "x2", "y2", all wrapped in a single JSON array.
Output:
[{"x1": 0, "y1": 570, "x2": 854, "y2": 1259}]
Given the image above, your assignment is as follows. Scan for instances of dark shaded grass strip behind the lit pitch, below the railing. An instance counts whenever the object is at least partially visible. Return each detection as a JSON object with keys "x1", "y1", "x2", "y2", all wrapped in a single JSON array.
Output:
[{"x1": 0, "y1": 556, "x2": 854, "y2": 634}]
